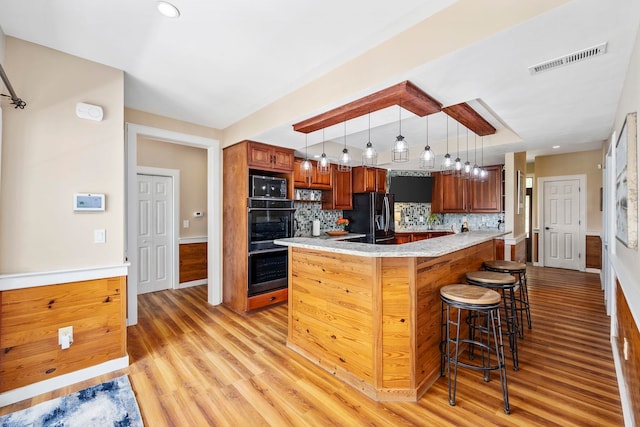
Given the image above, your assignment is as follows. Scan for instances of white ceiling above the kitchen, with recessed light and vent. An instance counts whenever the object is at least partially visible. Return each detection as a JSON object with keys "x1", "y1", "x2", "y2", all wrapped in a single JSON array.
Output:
[{"x1": 0, "y1": 0, "x2": 640, "y2": 168}]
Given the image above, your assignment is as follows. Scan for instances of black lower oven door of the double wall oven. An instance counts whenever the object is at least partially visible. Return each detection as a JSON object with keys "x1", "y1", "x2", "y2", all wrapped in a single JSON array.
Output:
[{"x1": 248, "y1": 248, "x2": 288, "y2": 297}]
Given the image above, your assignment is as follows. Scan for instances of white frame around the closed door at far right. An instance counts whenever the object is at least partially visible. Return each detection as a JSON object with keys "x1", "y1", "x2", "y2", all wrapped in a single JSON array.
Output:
[{"x1": 537, "y1": 174, "x2": 587, "y2": 271}]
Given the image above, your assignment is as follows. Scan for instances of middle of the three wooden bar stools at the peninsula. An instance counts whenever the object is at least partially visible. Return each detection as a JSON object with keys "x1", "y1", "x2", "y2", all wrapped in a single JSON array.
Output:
[{"x1": 466, "y1": 271, "x2": 519, "y2": 371}]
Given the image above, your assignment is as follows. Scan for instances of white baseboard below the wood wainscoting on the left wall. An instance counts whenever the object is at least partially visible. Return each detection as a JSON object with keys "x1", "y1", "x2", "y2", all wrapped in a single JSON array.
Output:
[{"x1": 0, "y1": 355, "x2": 129, "y2": 407}]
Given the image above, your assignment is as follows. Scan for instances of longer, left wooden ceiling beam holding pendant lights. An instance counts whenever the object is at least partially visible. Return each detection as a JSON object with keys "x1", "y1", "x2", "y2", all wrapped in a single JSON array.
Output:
[{"x1": 293, "y1": 81, "x2": 442, "y2": 133}]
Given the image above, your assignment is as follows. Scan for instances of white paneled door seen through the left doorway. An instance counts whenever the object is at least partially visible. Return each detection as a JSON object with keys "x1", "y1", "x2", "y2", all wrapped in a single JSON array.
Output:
[{"x1": 137, "y1": 174, "x2": 174, "y2": 294}]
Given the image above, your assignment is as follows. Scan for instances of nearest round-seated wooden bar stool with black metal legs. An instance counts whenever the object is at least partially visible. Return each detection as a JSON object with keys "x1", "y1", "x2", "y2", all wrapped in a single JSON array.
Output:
[{"x1": 440, "y1": 284, "x2": 510, "y2": 414}]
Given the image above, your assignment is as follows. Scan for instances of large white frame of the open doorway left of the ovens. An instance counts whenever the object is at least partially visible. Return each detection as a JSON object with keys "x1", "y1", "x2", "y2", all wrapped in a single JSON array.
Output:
[{"x1": 124, "y1": 123, "x2": 222, "y2": 325}]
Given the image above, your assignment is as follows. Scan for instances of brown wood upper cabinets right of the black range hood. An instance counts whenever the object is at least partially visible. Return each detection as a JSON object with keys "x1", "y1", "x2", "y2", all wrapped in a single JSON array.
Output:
[{"x1": 431, "y1": 165, "x2": 503, "y2": 213}]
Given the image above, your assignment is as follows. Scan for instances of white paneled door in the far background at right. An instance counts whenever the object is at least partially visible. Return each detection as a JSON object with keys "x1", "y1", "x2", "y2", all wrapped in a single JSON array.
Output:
[{"x1": 542, "y1": 179, "x2": 581, "y2": 270}]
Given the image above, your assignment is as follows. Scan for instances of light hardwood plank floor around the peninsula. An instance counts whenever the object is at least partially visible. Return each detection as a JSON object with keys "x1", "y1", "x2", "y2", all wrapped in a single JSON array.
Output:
[{"x1": 0, "y1": 267, "x2": 623, "y2": 427}]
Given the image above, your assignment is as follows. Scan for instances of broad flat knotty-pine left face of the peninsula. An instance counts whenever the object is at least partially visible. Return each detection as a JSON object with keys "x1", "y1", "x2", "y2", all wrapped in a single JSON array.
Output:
[{"x1": 287, "y1": 248, "x2": 376, "y2": 393}]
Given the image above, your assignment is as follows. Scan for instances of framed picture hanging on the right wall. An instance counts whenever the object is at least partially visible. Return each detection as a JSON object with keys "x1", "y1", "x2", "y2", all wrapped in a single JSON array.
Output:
[{"x1": 616, "y1": 112, "x2": 638, "y2": 249}]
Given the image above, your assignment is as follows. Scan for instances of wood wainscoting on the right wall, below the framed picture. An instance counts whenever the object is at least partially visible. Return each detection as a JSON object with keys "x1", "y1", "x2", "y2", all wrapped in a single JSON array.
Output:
[{"x1": 616, "y1": 280, "x2": 640, "y2": 422}]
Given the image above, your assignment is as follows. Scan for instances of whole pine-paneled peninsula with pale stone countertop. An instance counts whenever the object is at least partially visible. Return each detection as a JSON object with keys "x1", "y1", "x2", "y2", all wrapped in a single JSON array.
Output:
[{"x1": 276, "y1": 230, "x2": 505, "y2": 401}]
